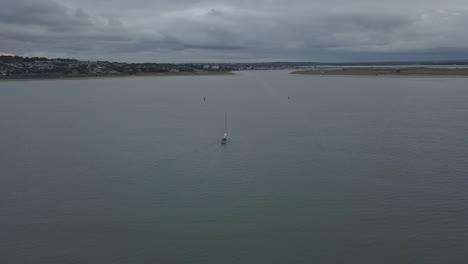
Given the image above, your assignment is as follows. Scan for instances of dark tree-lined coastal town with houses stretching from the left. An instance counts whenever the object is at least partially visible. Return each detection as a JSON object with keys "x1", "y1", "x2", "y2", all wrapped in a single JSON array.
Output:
[{"x1": 0, "y1": 54, "x2": 317, "y2": 79}]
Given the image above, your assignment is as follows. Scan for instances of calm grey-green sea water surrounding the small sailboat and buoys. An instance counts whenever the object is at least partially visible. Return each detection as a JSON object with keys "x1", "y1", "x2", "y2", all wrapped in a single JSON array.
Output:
[{"x1": 0, "y1": 71, "x2": 468, "y2": 264}]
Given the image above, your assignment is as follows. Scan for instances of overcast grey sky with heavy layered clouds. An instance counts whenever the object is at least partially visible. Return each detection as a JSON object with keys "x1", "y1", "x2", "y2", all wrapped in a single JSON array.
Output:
[{"x1": 0, "y1": 0, "x2": 468, "y2": 62}]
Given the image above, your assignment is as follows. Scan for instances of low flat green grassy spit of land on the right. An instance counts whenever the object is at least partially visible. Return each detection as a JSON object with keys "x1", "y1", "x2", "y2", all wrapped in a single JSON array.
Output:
[{"x1": 291, "y1": 67, "x2": 468, "y2": 77}]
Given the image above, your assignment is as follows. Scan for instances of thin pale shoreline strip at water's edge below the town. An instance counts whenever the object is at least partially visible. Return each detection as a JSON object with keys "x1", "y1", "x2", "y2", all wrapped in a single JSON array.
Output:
[{"x1": 0, "y1": 71, "x2": 235, "y2": 81}]
